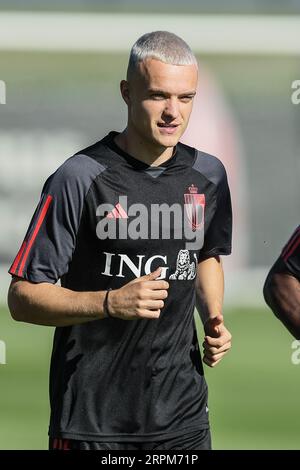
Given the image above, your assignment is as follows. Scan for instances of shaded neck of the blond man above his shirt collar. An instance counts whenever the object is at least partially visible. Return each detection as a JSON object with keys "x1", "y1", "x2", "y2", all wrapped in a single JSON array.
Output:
[{"x1": 115, "y1": 128, "x2": 174, "y2": 166}]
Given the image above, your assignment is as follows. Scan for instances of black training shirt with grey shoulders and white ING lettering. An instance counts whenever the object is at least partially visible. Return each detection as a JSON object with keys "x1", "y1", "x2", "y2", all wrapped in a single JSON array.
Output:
[{"x1": 9, "y1": 132, "x2": 232, "y2": 441}]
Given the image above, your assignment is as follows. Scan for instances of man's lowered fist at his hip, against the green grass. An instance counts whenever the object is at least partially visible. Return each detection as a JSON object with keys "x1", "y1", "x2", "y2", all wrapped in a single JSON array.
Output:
[{"x1": 203, "y1": 315, "x2": 232, "y2": 367}]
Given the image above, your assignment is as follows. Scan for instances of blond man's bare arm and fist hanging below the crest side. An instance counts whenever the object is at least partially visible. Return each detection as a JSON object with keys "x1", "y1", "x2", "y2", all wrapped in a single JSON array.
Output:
[{"x1": 196, "y1": 256, "x2": 231, "y2": 367}]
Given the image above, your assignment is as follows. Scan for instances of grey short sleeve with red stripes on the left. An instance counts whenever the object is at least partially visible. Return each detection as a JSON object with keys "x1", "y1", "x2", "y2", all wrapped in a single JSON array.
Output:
[{"x1": 9, "y1": 154, "x2": 103, "y2": 284}]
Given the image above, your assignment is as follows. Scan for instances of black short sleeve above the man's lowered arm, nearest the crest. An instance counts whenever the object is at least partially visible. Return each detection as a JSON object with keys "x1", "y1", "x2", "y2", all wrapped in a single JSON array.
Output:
[{"x1": 198, "y1": 162, "x2": 232, "y2": 262}]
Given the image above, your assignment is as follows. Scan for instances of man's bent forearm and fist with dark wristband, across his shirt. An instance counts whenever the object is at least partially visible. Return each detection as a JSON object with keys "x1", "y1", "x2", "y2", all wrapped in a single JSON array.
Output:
[{"x1": 8, "y1": 268, "x2": 169, "y2": 326}]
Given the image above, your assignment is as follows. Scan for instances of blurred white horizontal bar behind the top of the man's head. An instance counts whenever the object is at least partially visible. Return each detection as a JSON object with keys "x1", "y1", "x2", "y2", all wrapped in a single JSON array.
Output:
[{"x1": 0, "y1": 12, "x2": 300, "y2": 55}]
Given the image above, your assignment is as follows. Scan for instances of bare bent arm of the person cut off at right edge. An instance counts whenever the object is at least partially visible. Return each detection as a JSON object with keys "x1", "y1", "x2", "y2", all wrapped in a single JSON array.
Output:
[{"x1": 263, "y1": 263, "x2": 300, "y2": 339}]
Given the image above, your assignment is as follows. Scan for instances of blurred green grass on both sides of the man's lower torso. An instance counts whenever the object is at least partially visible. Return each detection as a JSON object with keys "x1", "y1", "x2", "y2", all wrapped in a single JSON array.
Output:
[{"x1": 0, "y1": 302, "x2": 300, "y2": 449}]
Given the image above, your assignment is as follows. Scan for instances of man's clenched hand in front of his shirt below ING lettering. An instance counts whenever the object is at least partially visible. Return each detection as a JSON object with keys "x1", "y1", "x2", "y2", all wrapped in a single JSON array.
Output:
[{"x1": 107, "y1": 268, "x2": 169, "y2": 320}]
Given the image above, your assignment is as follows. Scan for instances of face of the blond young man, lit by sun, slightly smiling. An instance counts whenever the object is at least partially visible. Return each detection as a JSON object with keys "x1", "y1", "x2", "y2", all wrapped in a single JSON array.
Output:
[{"x1": 121, "y1": 59, "x2": 198, "y2": 148}]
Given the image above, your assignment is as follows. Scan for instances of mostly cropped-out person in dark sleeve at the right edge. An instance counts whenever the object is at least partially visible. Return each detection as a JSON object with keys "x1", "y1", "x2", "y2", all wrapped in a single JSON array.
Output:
[{"x1": 264, "y1": 225, "x2": 300, "y2": 339}]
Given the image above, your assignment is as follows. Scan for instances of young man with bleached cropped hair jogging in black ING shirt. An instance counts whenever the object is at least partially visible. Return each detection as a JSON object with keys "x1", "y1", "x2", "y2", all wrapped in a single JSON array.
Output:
[{"x1": 9, "y1": 31, "x2": 231, "y2": 450}]
